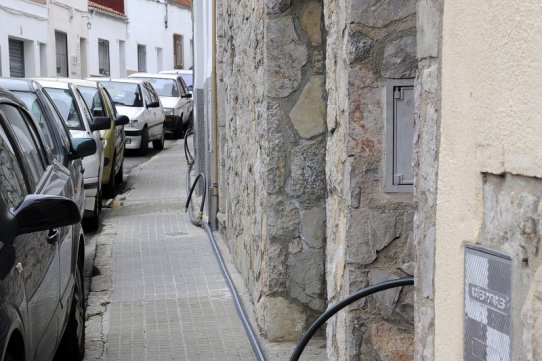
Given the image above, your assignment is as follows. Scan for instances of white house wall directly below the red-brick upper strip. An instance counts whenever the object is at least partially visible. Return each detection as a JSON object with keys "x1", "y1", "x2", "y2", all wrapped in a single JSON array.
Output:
[{"x1": 88, "y1": 11, "x2": 128, "y2": 78}]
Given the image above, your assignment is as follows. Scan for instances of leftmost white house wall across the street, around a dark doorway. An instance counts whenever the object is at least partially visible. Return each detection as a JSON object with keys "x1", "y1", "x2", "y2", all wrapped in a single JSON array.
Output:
[{"x1": 0, "y1": 0, "x2": 49, "y2": 77}]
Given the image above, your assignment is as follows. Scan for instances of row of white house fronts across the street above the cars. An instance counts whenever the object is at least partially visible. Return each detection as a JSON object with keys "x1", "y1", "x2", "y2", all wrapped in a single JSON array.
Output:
[{"x1": 0, "y1": 0, "x2": 193, "y2": 78}]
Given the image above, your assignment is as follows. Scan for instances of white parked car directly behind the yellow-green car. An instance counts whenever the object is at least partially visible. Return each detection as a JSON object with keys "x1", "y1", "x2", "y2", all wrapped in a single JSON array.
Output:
[{"x1": 93, "y1": 78, "x2": 165, "y2": 155}]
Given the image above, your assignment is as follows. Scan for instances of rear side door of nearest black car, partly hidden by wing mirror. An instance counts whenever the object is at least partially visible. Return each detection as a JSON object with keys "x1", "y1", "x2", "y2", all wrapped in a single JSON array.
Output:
[{"x1": 0, "y1": 103, "x2": 72, "y2": 360}]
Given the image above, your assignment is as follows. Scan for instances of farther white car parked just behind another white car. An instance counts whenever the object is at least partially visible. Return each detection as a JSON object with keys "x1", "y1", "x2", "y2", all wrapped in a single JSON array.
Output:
[{"x1": 128, "y1": 73, "x2": 193, "y2": 138}]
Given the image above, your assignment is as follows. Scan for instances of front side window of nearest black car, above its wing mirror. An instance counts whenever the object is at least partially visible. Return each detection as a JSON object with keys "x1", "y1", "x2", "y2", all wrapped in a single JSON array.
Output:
[{"x1": 0, "y1": 122, "x2": 27, "y2": 207}]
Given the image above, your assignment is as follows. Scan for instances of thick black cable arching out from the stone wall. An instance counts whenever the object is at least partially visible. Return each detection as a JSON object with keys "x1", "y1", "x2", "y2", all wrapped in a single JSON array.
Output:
[{"x1": 290, "y1": 277, "x2": 414, "y2": 361}]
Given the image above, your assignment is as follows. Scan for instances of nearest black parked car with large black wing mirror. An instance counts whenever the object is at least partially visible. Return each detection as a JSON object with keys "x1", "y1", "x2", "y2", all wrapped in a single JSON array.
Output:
[{"x1": 0, "y1": 89, "x2": 96, "y2": 361}]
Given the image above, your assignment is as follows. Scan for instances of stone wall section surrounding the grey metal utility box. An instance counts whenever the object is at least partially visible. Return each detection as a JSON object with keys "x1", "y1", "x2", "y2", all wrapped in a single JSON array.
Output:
[{"x1": 324, "y1": 0, "x2": 417, "y2": 361}]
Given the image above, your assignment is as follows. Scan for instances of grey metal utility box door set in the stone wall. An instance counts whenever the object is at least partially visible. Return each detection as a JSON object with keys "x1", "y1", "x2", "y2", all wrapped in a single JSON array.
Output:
[{"x1": 386, "y1": 79, "x2": 414, "y2": 192}]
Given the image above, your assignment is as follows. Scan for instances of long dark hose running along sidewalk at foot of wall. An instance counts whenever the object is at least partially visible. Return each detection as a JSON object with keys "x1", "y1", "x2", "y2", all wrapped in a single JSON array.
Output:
[{"x1": 184, "y1": 128, "x2": 266, "y2": 361}]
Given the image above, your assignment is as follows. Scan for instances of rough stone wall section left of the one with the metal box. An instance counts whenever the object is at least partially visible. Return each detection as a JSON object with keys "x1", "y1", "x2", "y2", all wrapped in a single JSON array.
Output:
[{"x1": 217, "y1": 0, "x2": 327, "y2": 340}]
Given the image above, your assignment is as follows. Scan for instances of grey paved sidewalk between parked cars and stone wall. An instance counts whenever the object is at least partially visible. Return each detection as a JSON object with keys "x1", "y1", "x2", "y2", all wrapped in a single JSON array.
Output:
[{"x1": 84, "y1": 140, "x2": 327, "y2": 361}]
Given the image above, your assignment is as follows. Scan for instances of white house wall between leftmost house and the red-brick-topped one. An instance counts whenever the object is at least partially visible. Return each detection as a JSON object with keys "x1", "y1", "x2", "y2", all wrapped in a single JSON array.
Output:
[{"x1": 46, "y1": 0, "x2": 89, "y2": 78}]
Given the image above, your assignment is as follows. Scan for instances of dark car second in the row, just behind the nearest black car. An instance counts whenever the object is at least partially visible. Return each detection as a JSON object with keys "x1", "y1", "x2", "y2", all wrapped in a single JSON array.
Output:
[{"x1": 0, "y1": 78, "x2": 87, "y2": 217}]
